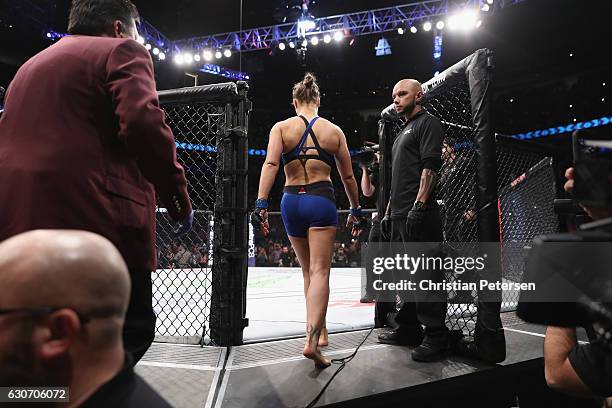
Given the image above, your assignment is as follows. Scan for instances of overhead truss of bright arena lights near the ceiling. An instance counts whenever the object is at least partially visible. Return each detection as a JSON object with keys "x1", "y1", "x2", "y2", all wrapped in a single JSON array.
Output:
[{"x1": 26, "y1": 0, "x2": 526, "y2": 77}]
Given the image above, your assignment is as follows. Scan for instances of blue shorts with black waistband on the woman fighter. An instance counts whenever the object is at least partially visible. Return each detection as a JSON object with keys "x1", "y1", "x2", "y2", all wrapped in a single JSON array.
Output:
[{"x1": 281, "y1": 181, "x2": 338, "y2": 238}]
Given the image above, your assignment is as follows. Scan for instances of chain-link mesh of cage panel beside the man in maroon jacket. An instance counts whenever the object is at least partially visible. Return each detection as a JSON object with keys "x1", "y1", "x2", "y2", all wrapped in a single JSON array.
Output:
[{"x1": 153, "y1": 83, "x2": 248, "y2": 344}]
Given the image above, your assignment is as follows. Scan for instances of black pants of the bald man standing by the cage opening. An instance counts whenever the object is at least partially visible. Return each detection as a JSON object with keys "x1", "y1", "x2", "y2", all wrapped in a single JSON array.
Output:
[{"x1": 391, "y1": 206, "x2": 448, "y2": 336}]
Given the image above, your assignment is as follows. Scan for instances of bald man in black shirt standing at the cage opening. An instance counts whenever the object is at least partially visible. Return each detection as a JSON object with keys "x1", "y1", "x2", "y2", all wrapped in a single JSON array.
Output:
[{"x1": 378, "y1": 79, "x2": 448, "y2": 361}]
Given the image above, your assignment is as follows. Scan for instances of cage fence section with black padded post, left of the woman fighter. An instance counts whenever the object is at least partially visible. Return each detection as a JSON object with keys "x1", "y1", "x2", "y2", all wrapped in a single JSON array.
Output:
[{"x1": 158, "y1": 82, "x2": 251, "y2": 346}]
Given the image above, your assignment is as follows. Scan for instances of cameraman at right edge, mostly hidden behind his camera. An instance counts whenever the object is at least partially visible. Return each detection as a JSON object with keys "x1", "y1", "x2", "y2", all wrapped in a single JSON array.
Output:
[{"x1": 544, "y1": 164, "x2": 612, "y2": 400}]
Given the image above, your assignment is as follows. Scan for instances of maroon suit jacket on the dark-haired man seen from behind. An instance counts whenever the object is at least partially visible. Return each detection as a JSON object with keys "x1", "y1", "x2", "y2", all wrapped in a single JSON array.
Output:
[{"x1": 0, "y1": 36, "x2": 191, "y2": 271}]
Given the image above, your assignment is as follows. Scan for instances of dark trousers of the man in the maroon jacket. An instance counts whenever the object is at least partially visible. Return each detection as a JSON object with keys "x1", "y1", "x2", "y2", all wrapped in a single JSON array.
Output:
[{"x1": 123, "y1": 269, "x2": 156, "y2": 365}]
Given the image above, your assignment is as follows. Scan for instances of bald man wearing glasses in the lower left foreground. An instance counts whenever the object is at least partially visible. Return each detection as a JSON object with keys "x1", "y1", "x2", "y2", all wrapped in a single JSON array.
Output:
[{"x1": 0, "y1": 230, "x2": 170, "y2": 408}]
